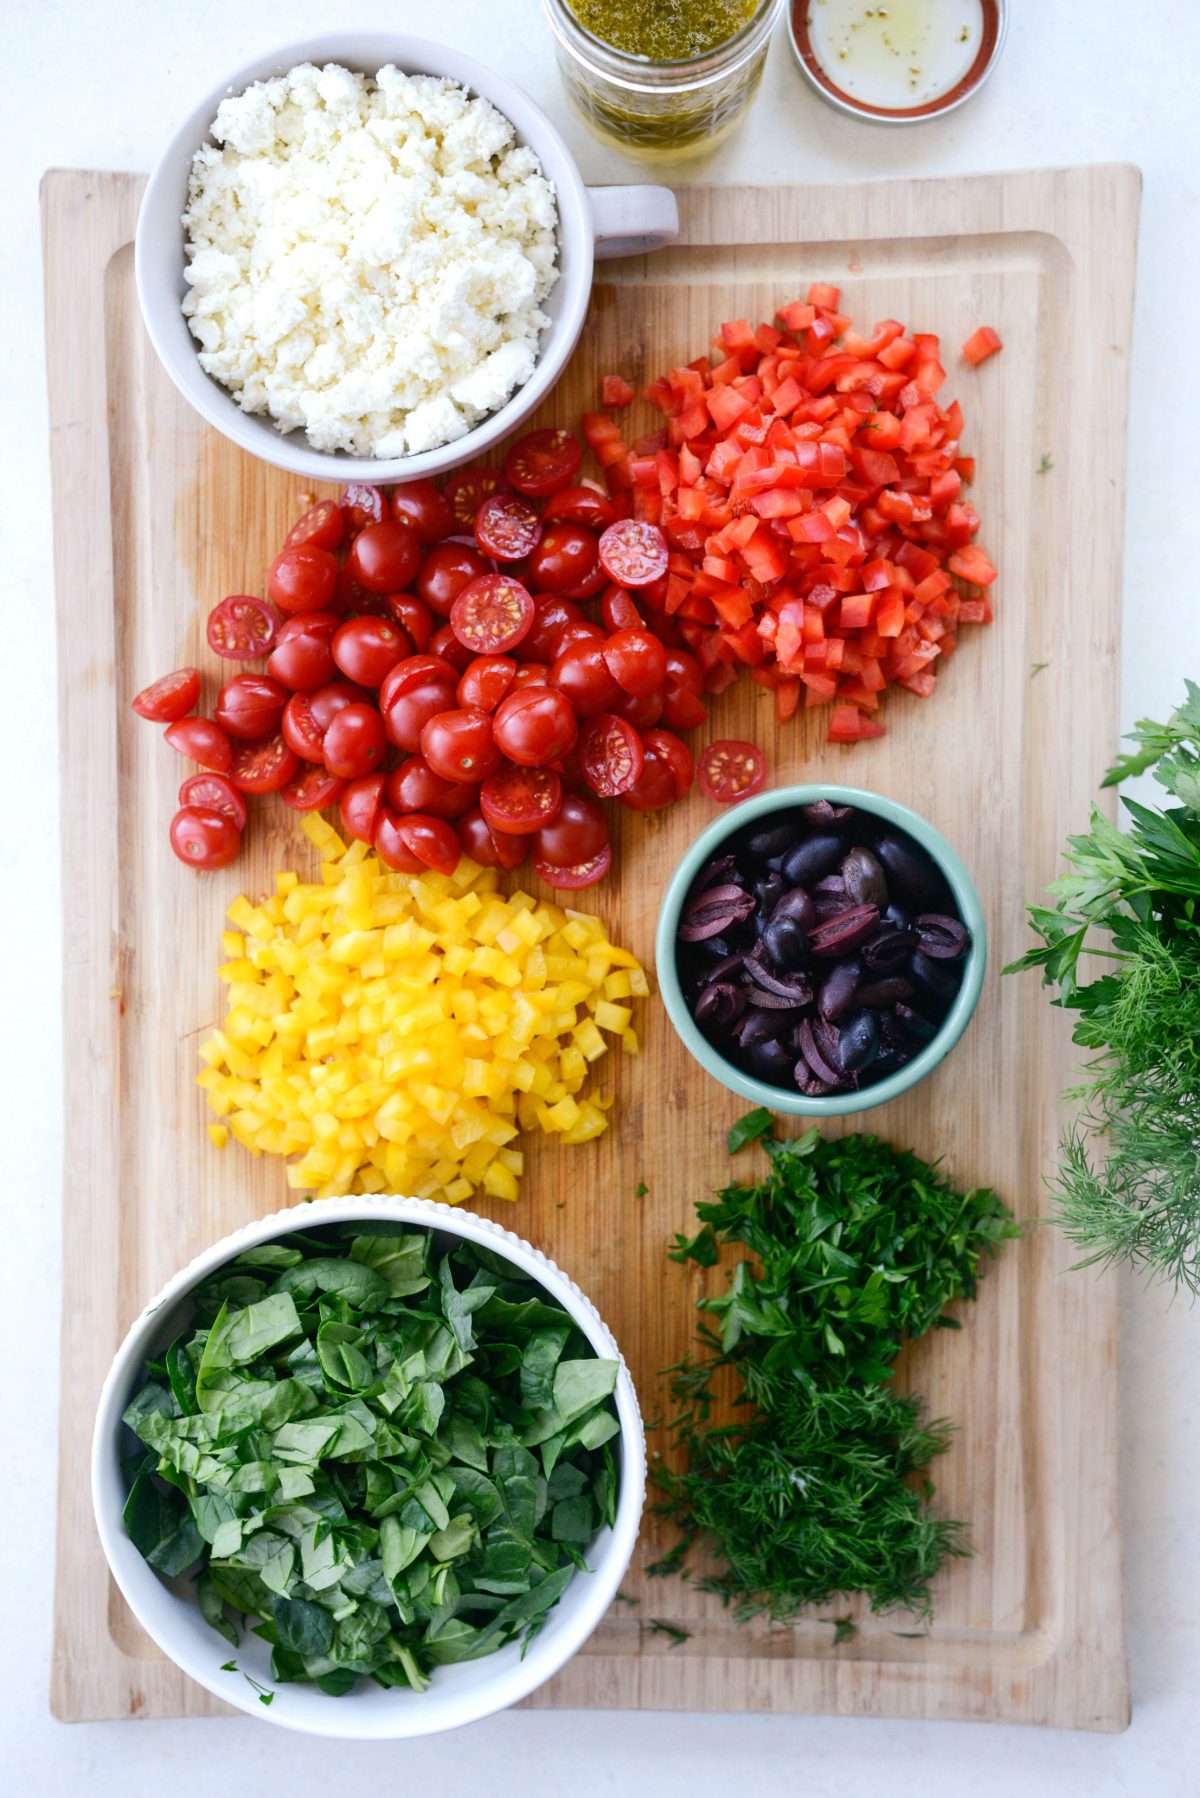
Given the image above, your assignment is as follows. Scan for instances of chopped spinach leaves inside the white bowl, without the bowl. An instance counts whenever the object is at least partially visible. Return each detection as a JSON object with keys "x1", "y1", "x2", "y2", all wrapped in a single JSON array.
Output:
[{"x1": 124, "y1": 1226, "x2": 619, "y2": 1696}]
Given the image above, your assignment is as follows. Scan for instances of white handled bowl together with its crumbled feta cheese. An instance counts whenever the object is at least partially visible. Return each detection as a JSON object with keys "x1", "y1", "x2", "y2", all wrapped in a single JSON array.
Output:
[{"x1": 135, "y1": 32, "x2": 676, "y2": 480}]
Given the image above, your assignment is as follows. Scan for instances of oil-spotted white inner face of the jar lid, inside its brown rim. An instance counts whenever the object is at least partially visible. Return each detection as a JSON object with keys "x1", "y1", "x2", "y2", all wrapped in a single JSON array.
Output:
[{"x1": 808, "y1": 0, "x2": 984, "y2": 111}]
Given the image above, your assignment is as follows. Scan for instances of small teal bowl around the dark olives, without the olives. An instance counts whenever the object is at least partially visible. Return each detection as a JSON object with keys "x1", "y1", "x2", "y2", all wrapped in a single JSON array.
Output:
[{"x1": 655, "y1": 786, "x2": 988, "y2": 1118}]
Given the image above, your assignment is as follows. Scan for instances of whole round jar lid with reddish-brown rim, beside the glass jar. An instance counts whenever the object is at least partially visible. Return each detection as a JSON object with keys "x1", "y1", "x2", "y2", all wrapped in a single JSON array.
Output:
[{"x1": 788, "y1": 0, "x2": 1007, "y2": 124}]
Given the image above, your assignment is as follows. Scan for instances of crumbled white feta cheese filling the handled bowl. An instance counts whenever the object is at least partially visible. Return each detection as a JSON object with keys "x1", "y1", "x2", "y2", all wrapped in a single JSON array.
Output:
[{"x1": 184, "y1": 63, "x2": 558, "y2": 458}]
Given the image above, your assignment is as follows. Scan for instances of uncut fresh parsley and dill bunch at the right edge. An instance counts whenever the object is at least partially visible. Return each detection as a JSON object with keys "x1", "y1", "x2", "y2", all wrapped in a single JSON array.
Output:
[{"x1": 1006, "y1": 681, "x2": 1200, "y2": 1293}]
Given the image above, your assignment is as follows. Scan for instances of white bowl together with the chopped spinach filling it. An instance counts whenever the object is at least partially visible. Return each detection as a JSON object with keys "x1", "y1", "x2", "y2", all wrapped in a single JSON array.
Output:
[{"x1": 92, "y1": 1199, "x2": 646, "y2": 1739}]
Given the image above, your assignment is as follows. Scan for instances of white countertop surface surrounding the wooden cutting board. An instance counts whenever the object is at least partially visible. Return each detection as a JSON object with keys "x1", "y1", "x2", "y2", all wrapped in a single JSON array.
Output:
[{"x1": 0, "y1": 0, "x2": 1200, "y2": 1798}]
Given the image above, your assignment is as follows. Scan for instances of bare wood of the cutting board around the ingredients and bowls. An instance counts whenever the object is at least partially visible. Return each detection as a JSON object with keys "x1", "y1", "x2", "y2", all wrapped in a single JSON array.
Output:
[{"x1": 43, "y1": 167, "x2": 1139, "y2": 1730}]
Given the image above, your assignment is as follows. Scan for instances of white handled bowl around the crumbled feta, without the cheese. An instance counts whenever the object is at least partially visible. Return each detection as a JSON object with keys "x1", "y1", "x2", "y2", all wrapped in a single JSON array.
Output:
[{"x1": 135, "y1": 31, "x2": 678, "y2": 482}]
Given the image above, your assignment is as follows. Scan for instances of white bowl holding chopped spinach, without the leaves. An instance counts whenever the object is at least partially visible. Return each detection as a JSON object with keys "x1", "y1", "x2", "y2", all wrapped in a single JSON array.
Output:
[{"x1": 92, "y1": 1197, "x2": 646, "y2": 1740}]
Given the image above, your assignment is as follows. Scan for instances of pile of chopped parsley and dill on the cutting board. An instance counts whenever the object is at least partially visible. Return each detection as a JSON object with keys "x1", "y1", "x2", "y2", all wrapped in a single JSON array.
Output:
[{"x1": 655, "y1": 1111, "x2": 1016, "y2": 1622}]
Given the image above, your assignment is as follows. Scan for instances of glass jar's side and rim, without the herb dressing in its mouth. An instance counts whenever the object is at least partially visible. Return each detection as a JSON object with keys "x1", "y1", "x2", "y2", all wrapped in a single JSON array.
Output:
[{"x1": 542, "y1": 0, "x2": 784, "y2": 158}]
